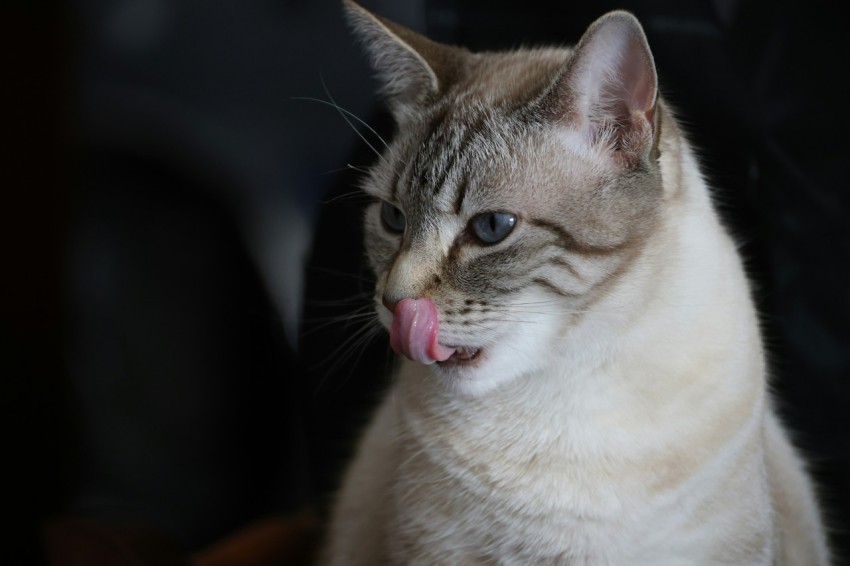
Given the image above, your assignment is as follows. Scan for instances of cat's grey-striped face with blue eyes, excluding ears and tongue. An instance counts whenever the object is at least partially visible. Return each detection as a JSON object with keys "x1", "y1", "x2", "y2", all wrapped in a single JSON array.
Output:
[{"x1": 346, "y1": 3, "x2": 661, "y2": 400}]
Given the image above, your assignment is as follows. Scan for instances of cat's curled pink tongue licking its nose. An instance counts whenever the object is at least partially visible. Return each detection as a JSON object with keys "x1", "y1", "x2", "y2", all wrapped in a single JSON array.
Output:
[{"x1": 390, "y1": 299, "x2": 454, "y2": 364}]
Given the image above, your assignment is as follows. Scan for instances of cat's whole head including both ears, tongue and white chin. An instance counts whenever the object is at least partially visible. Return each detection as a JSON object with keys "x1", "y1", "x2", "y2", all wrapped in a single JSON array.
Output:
[{"x1": 345, "y1": 2, "x2": 662, "y2": 400}]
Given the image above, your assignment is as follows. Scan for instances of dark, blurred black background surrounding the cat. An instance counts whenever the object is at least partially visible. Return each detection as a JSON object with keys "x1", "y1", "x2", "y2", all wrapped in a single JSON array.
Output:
[{"x1": 8, "y1": 0, "x2": 850, "y2": 564}]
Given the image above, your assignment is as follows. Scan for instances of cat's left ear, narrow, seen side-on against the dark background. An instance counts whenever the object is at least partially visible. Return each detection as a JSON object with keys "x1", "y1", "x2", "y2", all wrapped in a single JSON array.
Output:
[{"x1": 343, "y1": 0, "x2": 466, "y2": 120}]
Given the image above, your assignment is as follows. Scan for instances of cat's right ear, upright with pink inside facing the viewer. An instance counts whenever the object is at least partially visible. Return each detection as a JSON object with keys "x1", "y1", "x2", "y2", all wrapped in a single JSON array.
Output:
[{"x1": 553, "y1": 11, "x2": 658, "y2": 165}]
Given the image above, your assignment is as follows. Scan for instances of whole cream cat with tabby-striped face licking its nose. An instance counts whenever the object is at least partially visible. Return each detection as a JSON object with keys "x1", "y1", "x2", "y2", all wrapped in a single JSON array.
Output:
[{"x1": 320, "y1": 1, "x2": 830, "y2": 566}]
